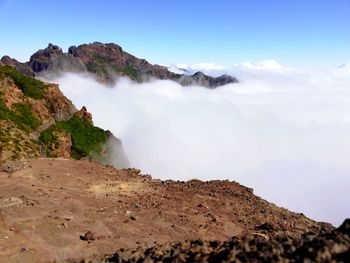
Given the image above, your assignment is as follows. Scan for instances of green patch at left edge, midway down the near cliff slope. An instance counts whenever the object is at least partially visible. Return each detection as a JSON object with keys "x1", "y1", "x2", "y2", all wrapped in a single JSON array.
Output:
[{"x1": 0, "y1": 98, "x2": 40, "y2": 131}]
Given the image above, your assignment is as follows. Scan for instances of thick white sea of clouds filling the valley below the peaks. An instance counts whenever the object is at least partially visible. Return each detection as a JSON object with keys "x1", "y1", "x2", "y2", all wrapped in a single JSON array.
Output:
[{"x1": 49, "y1": 70, "x2": 350, "y2": 227}]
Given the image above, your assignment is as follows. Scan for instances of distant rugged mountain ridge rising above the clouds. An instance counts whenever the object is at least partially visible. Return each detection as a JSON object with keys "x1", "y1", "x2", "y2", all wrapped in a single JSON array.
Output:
[{"x1": 1, "y1": 42, "x2": 238, "y2": 88}]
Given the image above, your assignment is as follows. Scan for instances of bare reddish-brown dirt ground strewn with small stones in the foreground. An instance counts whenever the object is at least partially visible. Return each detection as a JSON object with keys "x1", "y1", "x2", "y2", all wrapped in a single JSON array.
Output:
[{"x1": 0, "y1": 159, "x2": 331, "y2": 262}]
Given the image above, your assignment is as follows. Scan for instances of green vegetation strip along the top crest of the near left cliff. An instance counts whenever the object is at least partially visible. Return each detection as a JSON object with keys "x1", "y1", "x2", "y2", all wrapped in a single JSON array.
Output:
[{"x1": 0, "y1": 65, "x2": 47, "y2": 99}]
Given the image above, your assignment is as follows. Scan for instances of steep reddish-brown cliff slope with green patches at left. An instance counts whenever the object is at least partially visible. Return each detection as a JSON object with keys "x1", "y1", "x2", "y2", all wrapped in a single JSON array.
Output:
[{"x1": 0, "y1": 65, "x2": 127, "y2": 165}]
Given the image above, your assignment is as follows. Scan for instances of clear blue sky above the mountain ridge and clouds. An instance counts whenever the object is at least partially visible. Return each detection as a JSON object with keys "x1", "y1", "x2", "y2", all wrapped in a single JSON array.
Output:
[{"x1": 0, "y1": 0, "x2": 350, "y2": 67}]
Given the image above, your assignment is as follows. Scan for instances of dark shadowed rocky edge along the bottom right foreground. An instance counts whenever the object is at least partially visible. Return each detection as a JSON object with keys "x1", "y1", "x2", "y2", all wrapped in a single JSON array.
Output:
[{"x1": 76, "y1": 219, "x2": 350, "y2": 263}]
